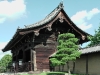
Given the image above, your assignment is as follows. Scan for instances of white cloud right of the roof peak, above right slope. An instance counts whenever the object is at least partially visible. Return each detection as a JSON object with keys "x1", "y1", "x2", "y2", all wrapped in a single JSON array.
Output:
[{"x1": 71, "y1": 8, "x2": 100, "y2": 30}]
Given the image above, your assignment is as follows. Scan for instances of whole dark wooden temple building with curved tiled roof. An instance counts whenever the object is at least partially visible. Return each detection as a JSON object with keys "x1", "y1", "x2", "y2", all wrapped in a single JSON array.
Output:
[{"x1": 2, "y1": 2, "x2": 89, "y2": 72}]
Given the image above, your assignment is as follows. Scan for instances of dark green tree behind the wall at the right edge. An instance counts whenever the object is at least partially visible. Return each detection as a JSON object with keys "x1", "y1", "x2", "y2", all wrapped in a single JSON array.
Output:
[{"x1": 88, "y1": 26, "x2": 100, "y2": 46}]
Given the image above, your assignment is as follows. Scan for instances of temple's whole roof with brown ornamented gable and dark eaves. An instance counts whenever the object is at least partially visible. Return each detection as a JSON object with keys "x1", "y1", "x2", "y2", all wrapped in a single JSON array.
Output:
[{"x1": 2, "y1": 2, "x2": 90, "y2": 51}]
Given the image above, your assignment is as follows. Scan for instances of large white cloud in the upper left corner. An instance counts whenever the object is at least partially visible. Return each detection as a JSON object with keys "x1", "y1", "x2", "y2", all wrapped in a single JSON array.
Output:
[{"x1": 0, "y1": 0, "x2": 26, "y2": 23}]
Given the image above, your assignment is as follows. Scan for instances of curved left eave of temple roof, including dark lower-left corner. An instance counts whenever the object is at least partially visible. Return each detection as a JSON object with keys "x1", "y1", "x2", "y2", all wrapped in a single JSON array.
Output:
[{"x1": 2, "y1": 2, "x2": 63, "y2": 52}]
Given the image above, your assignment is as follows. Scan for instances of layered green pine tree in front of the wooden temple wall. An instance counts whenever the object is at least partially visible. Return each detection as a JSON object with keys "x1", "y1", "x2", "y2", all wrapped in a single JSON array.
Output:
[{"x1": 50, "y1": 33, "x2": 81, "y2": 74}]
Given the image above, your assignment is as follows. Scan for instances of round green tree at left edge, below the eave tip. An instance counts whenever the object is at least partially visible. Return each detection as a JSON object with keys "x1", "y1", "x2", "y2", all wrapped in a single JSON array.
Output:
[{"x1": 0, "y1": 54, "x2": 12, "y2": 72}]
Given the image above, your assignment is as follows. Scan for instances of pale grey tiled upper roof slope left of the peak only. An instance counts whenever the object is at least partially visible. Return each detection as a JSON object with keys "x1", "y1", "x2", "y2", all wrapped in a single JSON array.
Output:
[{"x1": 21, "y1": 2, "x2": 64, "y2": 29}]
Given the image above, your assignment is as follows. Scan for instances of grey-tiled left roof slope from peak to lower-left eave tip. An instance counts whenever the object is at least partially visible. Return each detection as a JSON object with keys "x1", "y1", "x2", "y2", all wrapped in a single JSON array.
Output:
[{"x1": 2, "y1": 2, "x2": 64, "y2": 51}]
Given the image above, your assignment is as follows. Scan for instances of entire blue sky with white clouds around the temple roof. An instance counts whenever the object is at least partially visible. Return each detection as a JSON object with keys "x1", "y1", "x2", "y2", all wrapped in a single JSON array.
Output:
[{"x1": 0, "y1": 0, "x2": 100, "y2": 58}]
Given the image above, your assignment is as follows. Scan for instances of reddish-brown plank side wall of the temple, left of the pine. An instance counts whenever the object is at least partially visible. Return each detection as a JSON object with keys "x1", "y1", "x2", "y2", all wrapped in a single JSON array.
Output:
[{"x1": 35, "y1": 34, "x2": 56, "y2": 71}]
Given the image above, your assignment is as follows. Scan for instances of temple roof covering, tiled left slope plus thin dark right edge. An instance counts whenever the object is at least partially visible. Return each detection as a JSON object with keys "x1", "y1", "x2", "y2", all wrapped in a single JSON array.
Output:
[{"x1": 2, "y1": 2, "x2": 90, "y2": 51}]
